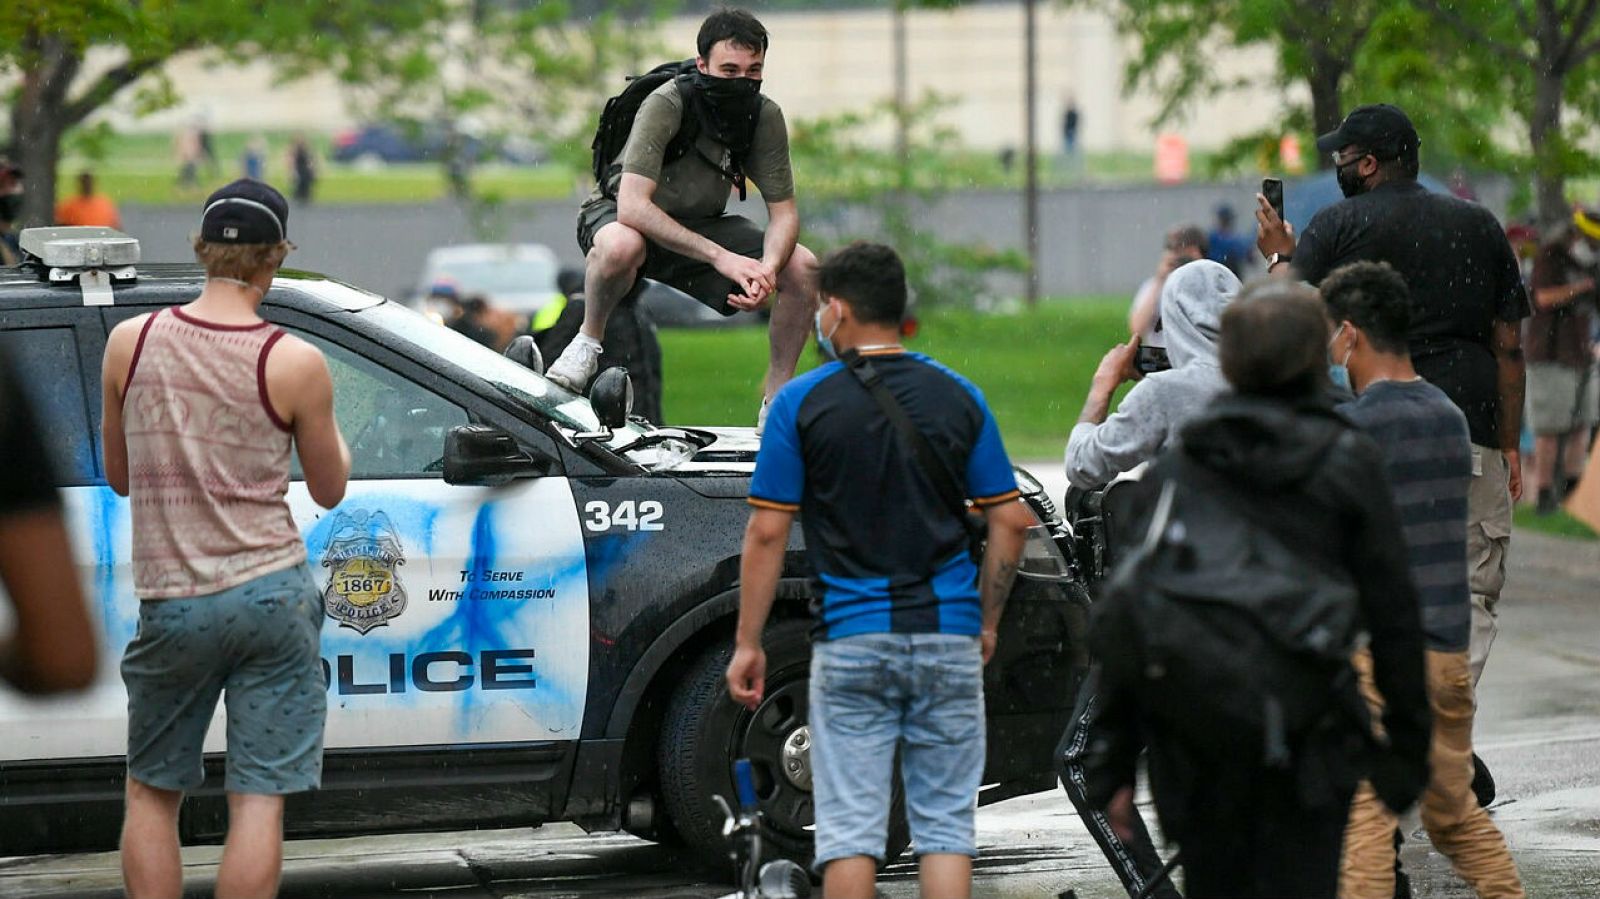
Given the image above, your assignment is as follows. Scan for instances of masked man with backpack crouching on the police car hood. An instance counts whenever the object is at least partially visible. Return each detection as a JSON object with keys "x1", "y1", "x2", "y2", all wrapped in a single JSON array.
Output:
[{"x1": 546, "y1": 10, "x2": 816, "y2": 429}]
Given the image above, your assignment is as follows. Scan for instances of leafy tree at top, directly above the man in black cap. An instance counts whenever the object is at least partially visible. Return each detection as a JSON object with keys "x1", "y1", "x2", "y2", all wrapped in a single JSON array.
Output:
[{"x1": 1078, "y1": 0, "x2": 1390, "y2": 166}]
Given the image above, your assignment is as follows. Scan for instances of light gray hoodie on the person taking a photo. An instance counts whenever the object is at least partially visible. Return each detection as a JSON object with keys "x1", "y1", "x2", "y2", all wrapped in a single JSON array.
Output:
[{"x1": 1067, "y1": 259, "x2": 1238, "y2": 489}]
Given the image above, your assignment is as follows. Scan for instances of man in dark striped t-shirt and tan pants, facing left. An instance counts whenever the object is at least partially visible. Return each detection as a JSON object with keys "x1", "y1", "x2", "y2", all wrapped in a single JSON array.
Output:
[{"x1": 1322, "y1": 262, "x2": 1525, "y2": 899}]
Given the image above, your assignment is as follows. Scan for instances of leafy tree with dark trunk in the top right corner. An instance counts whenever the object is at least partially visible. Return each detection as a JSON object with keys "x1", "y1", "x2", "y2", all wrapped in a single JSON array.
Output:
[{"x1": 1413, "y1": 0, "x2": 1600, "y2": 222}]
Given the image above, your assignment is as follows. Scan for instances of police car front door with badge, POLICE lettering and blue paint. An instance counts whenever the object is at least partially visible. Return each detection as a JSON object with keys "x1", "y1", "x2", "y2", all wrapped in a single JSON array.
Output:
[{"x1": 290, "y1": 328, "x2": 589, "y2": 750}]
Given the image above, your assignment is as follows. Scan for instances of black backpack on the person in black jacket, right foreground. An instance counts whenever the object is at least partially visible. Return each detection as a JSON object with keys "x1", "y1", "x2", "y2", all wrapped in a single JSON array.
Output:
[{"x1": 1091, "y1": 453, "x2": 1358, "y2": 768}]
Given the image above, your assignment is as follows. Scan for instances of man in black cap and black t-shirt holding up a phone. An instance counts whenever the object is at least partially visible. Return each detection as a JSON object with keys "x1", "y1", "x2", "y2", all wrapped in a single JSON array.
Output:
[{"x1": 1256, "y1": 104, "x2": 1530, "y2": 800}]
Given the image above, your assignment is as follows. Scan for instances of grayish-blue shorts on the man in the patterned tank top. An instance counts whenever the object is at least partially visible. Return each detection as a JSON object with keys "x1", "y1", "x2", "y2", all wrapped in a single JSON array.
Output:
[{"x1": 122, "y1": 563, "x2": 328, "y2": 795}]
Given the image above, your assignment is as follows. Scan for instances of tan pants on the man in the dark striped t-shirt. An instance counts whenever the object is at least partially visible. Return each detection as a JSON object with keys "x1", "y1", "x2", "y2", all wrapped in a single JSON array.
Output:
[{"x1": 1339, "y1": 649, "x2": 1526, "y2": 899}]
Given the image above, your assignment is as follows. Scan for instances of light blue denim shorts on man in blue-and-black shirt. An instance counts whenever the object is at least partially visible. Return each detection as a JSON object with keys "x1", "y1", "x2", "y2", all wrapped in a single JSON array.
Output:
[{"x1": 810, "y1": 633, "x2": 984, "y2": 870}]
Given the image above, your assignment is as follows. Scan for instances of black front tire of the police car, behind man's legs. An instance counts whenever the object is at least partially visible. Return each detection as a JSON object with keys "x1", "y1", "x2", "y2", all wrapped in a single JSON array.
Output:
[{"x1": 658, "y1": 619, "x2": 910, "y2": 869}]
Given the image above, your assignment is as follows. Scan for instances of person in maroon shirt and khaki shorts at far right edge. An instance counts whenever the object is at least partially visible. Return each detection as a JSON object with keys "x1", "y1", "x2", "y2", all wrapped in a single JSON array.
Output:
[{"x1": 1522, "y1": 211, "x2": 1600, "y2": 515}]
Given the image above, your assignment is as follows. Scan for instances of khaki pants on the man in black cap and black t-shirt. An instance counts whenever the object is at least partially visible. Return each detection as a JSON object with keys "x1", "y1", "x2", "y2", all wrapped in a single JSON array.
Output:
[{"x1": 1467, "y1": 445, "x2": 1510, "y2": 686}]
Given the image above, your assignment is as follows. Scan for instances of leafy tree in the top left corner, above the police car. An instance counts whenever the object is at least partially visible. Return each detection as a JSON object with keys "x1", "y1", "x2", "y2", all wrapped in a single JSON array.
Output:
[{"x1": 0, "y1": 0, "x2": 445, "y2": 226}]
